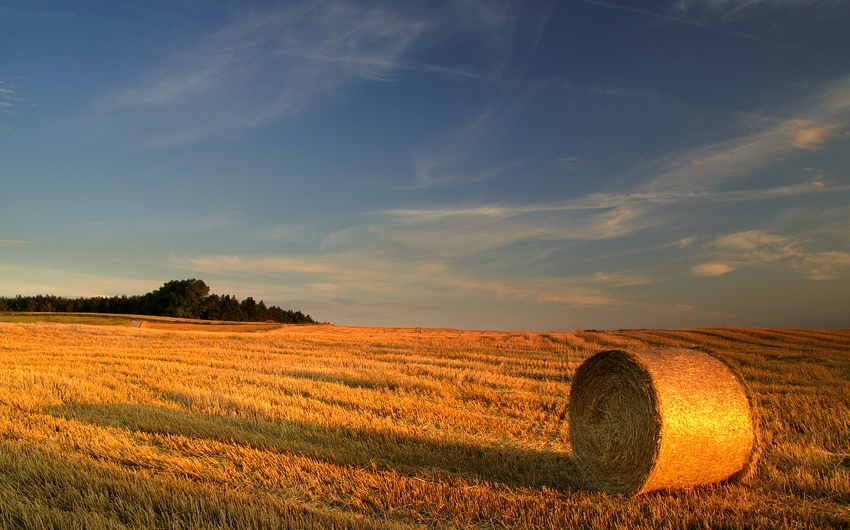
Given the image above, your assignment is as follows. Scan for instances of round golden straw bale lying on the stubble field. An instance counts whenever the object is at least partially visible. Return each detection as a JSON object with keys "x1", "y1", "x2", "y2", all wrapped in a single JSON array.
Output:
[{"x1": 570, "y1": 349, "x2": 757, "y2": 494}]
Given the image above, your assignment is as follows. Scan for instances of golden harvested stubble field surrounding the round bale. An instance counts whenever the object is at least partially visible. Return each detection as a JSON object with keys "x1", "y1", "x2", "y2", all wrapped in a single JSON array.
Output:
[{"x1": 0, "y1": 321, "x2": 850, "y2": 528}]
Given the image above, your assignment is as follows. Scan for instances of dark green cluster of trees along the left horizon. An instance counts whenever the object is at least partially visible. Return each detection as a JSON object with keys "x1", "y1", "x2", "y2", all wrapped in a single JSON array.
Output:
[{"x1": 0, "y1": 279, "x2": 315, "y2": 324}]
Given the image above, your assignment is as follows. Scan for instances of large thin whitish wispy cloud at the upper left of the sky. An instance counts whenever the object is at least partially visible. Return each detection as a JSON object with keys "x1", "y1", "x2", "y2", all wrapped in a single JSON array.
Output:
[{"x1": 91, "y1": 1, "x2": 507, "y2": 146}]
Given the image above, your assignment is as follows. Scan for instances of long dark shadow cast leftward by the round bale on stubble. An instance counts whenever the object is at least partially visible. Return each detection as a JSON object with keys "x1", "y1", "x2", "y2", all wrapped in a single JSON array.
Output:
[{"x1": 45, "y1": 403, "x2": 579, "y2": 490}]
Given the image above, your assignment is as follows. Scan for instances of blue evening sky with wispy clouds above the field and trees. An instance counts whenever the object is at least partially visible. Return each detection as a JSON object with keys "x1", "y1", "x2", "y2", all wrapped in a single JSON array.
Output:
[{"x1": 0, "y1": 0, "x2": 850, "y2": 331}]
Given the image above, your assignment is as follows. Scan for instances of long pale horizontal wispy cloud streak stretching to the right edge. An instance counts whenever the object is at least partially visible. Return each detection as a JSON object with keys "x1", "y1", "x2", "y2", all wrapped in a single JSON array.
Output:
[{"x1": 364, "y1": 178, "x2": 850, "y2": 257}]
